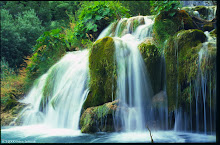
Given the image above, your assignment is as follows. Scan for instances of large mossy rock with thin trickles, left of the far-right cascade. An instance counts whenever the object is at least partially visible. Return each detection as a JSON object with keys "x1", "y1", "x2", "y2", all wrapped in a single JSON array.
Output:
[{"x1": 165, "y1": 29, "x2": 206, "y2": 110}]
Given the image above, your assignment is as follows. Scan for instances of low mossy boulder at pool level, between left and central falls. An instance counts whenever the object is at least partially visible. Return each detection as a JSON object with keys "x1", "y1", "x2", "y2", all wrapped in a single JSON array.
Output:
[{"x1": 80, "y1": 100, "x2": 118, "y2": 133}]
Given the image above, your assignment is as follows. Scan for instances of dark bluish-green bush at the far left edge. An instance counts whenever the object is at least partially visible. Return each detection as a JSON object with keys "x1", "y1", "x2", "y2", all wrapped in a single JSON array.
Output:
[{"x1": 1, "y1": 9, "x2": 44, "y2": 68}]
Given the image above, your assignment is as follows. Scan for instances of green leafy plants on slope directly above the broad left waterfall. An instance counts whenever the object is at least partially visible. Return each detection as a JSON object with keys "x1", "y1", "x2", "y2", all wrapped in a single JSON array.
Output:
[{"x1": 27, "y1": 29, "x2": 69, "y2": 87}]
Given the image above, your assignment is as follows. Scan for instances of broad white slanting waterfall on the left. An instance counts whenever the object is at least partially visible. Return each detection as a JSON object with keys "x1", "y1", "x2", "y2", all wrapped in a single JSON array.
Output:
[{"x1": 17, "y1": 50, "x2": 88, "y2": 130}]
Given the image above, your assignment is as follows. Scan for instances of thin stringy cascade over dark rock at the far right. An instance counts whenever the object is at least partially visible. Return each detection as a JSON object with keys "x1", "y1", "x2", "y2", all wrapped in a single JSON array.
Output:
[{"x1": 174, "y1": 31, "x2": 216, "y2": 134}]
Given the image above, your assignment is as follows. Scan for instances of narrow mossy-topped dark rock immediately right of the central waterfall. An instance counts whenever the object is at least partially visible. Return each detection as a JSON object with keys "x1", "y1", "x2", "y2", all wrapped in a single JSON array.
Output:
[{"x1": 138, "y1": 39, "x2": 164, "y2": 94}]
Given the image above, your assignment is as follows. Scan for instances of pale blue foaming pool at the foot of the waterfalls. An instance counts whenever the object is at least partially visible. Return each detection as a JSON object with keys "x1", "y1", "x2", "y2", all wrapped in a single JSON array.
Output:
[{"x1": 1, "y1": 125, "x2": 216, "y2": 143}]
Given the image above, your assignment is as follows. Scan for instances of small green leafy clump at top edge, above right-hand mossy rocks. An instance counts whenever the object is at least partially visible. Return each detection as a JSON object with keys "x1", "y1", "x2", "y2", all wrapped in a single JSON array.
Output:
[{"x1": 150, "y1": 1, "x2": 181, "y2": 17}]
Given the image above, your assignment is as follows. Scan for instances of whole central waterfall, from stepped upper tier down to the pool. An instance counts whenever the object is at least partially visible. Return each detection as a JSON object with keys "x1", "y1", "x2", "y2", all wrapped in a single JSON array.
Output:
[{"x1": 99, "y1": 16, "x2": 168, "y2": 132}]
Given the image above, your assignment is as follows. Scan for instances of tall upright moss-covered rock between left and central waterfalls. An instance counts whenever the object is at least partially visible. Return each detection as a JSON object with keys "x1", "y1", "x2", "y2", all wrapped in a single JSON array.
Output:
[{"x1": 83, "y1": 37, "x2": 116, "y2": 109}]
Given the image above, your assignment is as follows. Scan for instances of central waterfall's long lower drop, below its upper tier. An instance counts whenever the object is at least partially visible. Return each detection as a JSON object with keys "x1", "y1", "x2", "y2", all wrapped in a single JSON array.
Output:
[{"x1": 112, "y1": 34, "x2": 150, "y2": 131}]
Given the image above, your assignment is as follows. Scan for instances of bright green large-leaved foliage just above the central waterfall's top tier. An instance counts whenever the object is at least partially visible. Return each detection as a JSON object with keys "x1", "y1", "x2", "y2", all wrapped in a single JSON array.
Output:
[{"x1": 74, "y1": 1, "x2": 128, "y2": 39}]
